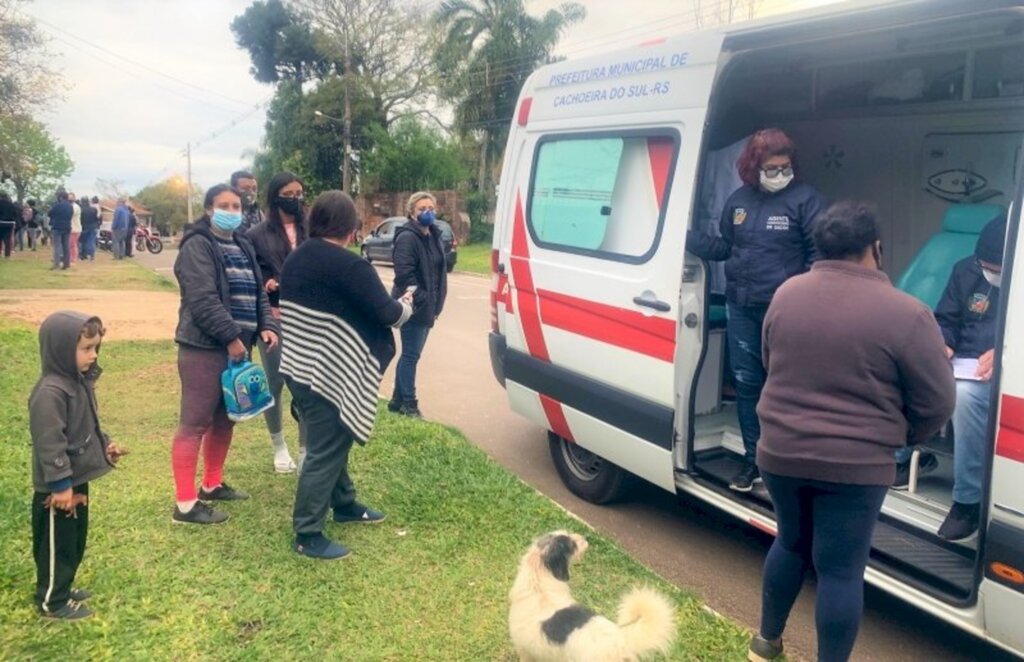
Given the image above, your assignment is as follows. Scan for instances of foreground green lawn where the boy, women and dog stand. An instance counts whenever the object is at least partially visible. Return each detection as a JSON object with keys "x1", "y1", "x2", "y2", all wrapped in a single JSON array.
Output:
[{"x1": 0, "y1": 319, "x2": 746, "y2": 661}]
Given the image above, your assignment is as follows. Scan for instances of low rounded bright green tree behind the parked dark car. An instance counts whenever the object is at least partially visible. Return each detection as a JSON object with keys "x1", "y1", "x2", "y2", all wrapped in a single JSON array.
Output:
[{"x1": 359, "y1": 117, "x2": 469, "y2": 191}]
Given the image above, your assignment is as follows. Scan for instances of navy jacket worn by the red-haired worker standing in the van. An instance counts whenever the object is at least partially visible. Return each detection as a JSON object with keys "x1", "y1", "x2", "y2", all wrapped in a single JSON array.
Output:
[{"x1": 686, "y1": 181, "x2": 825, "y2": 306}]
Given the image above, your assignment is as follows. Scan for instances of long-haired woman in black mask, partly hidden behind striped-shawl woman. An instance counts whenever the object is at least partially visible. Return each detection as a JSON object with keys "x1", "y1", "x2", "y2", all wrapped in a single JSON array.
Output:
[{"x1": 246, "y1": 172, "x2": 306, "y2": 473}]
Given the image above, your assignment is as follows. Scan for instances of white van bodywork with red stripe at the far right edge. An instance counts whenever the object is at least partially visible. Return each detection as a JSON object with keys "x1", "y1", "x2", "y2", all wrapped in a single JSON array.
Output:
[{"x1": 979, "y1": 146, "x2": 1024, "y2": 651}]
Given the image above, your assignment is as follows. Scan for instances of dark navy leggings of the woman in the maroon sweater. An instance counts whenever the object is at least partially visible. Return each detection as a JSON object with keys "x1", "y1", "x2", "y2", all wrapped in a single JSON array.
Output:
[{"x1": 761, "y1": 472, "x2": 889, "y2": 662}]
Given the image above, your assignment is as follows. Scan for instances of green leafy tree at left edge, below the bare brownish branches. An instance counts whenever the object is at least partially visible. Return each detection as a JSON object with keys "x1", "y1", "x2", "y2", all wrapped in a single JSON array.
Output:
[{"x1": 0, "y1": 115, "x2": 75, "y2": 203}]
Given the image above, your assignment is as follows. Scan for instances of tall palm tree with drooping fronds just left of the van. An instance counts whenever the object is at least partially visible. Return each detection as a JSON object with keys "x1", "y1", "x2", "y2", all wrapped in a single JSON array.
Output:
[{"x1": 433, "y1": 0, "x2": 586, "y2": 196}]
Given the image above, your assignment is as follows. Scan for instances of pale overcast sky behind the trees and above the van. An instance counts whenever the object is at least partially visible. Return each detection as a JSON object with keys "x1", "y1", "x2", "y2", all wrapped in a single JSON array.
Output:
[{"x1": 25, "y1": 0, "x2": 829, "y2": 195}]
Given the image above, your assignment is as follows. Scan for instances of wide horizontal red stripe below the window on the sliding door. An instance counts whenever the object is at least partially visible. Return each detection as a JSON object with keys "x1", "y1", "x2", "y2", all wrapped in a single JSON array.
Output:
[{"x1": 538, "y1": 290, "x2": 676, "y2": 363}]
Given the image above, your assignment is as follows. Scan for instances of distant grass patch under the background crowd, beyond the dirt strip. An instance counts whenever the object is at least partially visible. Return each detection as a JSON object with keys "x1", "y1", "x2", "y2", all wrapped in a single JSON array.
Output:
[{"x1": 0, "y1": 246, "x2": 178, "y2": 291}]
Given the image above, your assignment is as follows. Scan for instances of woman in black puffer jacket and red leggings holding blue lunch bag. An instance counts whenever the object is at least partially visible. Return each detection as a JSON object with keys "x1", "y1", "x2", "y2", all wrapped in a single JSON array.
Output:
[{"x1": 171, "y1": 183, "x2": 278, "y2": 524}]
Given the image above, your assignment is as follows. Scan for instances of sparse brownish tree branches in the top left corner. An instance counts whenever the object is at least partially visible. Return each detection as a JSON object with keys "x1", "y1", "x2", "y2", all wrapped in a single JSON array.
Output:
[{"x1": 0, "y1": 0, "x2": 59, "y2": 115}]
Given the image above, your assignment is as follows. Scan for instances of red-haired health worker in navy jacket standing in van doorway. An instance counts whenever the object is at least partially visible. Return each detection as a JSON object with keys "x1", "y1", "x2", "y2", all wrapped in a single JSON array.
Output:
[{"x1": 686, "y1": 129, "x2": 825, "y2": 492}]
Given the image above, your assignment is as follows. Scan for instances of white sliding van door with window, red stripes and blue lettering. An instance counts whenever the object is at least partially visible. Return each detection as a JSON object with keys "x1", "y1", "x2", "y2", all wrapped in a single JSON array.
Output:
[{"x1": 499, "y1": 33, "x2": 722, "y2": 498}]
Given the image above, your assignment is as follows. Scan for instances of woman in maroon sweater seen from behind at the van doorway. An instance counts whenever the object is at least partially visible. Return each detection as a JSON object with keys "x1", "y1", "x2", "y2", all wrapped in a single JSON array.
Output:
[{"x1": 750, "y1": 202, "x2": 955, "y2": 662}]
